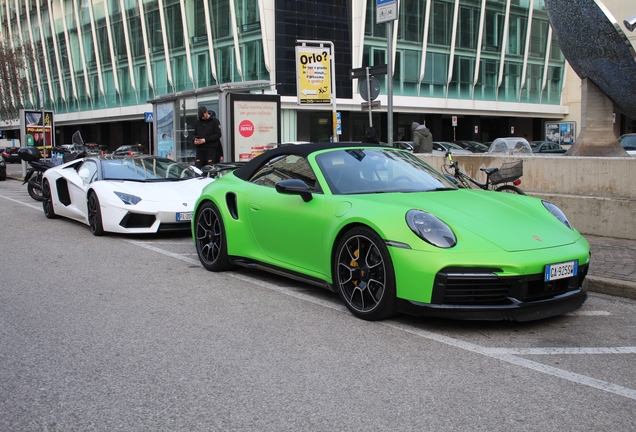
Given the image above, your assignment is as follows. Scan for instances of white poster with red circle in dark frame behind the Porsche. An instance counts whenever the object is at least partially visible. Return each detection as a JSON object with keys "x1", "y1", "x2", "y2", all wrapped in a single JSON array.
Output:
[{"x1": 230, "y1": 93, "x2": 280, "y2": 161}]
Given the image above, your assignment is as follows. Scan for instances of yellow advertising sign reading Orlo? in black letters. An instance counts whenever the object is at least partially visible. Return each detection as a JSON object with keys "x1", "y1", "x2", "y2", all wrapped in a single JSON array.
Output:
[{"x1": 296, "y1": 46, "x2": 331, "y2": 104}]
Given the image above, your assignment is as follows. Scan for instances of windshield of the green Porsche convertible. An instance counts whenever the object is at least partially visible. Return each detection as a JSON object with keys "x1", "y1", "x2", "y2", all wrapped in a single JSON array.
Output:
[{"x1": 316, "y1": 148, "x2": 457, "y2": 194}]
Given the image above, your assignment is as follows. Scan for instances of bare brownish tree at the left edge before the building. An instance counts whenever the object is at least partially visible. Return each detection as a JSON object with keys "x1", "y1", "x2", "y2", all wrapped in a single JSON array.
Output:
[{"x1": 0, "y1": 40, "x2": 36, "y2": 121}]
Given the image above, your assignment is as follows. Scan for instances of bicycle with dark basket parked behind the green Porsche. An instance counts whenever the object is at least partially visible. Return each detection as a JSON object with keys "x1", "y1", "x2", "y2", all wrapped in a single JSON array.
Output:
[{"x1": 443, "y1": 151, "x2": 525, "y2": 195}]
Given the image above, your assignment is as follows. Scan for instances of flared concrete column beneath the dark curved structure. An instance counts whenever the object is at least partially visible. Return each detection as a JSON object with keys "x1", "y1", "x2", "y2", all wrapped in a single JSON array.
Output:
[{"x1": 566, "y1": 78, "x2": 627, "y2": 156}]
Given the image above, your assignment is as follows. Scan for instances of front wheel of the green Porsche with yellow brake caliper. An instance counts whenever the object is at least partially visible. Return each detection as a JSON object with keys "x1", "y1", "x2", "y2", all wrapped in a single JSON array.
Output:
[{"x1": 334, "y1": 227, "x2": 396, "y2": 320}]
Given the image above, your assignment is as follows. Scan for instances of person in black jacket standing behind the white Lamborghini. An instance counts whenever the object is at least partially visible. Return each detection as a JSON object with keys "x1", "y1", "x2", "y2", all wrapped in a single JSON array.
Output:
[{"x1": 194, "y1": 106, "x2": 223, "y2": 168}]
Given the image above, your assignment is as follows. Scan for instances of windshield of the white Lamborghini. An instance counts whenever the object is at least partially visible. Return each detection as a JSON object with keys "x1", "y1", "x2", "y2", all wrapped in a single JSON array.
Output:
[{"x1": 102, "y1": 156, "x2": 197, "y2": 182}]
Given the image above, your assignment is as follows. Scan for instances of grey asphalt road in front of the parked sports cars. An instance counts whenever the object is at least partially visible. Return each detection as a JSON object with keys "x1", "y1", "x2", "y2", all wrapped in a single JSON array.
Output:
[{"x1": 0, "y1": 181, "x2": 636, "y2": 431}]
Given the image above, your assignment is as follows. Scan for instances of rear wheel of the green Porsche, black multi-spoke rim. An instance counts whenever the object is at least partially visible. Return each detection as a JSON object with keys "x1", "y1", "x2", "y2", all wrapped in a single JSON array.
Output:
[{"x1": 194, "y1": 202, "x2": 233, "y2": 272}]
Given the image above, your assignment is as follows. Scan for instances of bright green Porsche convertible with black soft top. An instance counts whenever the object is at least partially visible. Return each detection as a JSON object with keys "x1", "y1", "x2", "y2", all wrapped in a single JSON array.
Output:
[{"x1": 192, "y1": 143, "x2": 589, "y2": 321}]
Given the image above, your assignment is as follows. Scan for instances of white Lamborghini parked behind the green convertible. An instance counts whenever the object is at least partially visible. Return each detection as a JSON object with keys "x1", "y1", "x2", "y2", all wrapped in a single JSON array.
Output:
[{"x1": 42, "y1": 155, "x2": 213, "y2": 235}]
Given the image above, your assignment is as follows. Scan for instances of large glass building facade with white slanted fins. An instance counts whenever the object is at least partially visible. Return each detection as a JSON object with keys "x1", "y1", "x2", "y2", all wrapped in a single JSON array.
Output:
[{"x1": 0, "y1": 0, "x2": 565, "y2": 149}]
